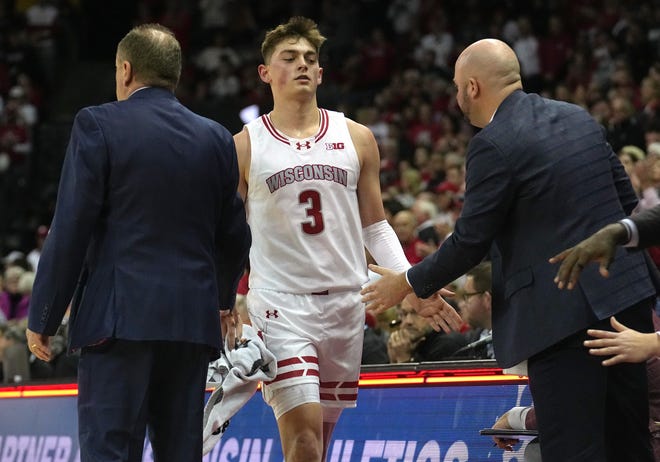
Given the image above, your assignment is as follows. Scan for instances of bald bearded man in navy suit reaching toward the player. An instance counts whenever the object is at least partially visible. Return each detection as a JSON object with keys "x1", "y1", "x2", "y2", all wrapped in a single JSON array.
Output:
[{"x1": 363, "y1": 39, "x2": 655, "y2": 462}]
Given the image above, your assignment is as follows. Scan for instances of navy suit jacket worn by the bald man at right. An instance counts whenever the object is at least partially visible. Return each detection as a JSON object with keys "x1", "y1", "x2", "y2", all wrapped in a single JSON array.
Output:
[{"x1": 408, "y1": 91, "x2": 655, "y2": 367}]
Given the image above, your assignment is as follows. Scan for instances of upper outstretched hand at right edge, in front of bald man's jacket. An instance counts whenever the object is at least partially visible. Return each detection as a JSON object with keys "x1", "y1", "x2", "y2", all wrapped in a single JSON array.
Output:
[{"x1": 550, "y1": 223, "x2": 626, "y2": 290}]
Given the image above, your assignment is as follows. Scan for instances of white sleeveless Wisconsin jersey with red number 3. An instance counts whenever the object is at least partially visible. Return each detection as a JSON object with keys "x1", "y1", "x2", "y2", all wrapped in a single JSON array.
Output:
[{"x1": 246, "y1": 109, "x2": 367, "y2": 293}]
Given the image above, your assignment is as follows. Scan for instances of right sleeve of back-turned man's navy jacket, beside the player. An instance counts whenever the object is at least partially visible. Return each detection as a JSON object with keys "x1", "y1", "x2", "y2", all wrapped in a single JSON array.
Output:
[{"x1": 216, "y1": 136, "x2": 252, "y2": 309}]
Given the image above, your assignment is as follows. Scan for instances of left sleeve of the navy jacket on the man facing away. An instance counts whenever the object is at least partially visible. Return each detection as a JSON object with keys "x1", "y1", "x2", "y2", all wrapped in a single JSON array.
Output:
[{"x1": 28, "y1": 109, "x2": 108, "y2": 335}]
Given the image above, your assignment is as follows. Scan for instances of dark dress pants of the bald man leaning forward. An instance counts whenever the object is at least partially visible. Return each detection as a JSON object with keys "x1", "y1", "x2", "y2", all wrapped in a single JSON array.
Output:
[{"x1": 527, "y1": 300, "x2": 653, "y2": 462}]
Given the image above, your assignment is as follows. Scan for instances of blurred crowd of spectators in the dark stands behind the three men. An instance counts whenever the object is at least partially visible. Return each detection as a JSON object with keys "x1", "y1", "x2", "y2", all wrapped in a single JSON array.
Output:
[{"x1": 0, "y1": 0, "x2": 660, "y2": 382}]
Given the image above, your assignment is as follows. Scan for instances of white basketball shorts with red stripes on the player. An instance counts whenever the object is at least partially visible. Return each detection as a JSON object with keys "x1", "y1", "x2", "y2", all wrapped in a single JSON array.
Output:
[{"x1": 247, "y1": 289, "x2": 365, "y2": 408}]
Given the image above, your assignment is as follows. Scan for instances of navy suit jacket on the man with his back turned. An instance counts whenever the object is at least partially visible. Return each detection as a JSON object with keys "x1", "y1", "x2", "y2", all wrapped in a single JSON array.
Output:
[{"x1": 28, "y1": 87, "x2": 251, "y2": 358}]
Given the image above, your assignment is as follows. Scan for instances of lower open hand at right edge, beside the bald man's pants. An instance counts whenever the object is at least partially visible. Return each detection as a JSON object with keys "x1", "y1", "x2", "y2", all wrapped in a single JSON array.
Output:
[{"x1": 584, "y1": 316, "x2": 660, "y2": 366}]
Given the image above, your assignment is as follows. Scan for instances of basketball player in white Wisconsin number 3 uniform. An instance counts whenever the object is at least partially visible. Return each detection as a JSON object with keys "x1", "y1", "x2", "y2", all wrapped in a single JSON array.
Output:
[{"x1": 234, "y1": 17, "x2": 460, "y2": 462}]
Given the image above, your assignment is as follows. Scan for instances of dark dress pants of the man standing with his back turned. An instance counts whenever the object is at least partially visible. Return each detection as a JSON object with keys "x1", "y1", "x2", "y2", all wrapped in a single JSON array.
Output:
[{"x1": 78, "y1": 339, "x2": 209, "y2": 462}]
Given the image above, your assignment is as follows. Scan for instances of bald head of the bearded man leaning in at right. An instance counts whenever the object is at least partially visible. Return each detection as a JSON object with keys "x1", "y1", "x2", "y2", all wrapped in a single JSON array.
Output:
[{"x1": 454, "y1": 39, "x2": 522, "y2": 127}]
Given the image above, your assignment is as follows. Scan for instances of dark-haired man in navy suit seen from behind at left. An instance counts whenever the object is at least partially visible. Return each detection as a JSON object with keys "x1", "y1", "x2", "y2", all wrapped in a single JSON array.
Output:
[{"x1": 28, "y1": 24, "x2": 250, "y2": 462}]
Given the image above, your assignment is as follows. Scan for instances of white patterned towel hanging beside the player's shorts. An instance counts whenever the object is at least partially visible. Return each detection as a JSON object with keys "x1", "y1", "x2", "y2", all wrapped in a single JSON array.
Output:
[{"x1": 203, "y1": 324, "x2": 277, "y2": 455}]
